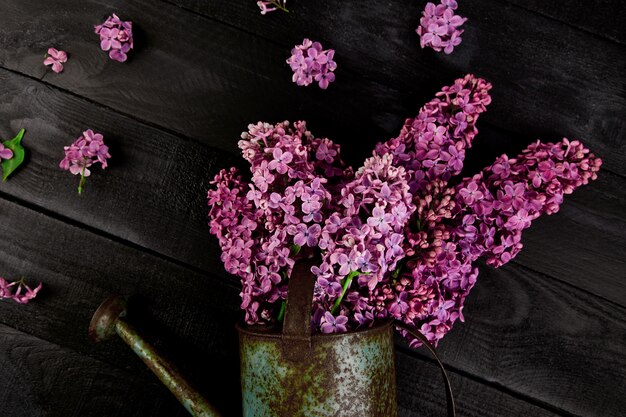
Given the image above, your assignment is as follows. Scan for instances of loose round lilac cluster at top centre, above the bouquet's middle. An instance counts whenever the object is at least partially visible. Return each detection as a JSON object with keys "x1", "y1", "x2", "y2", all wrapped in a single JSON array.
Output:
[{"x1": 287, "y1": 39, "x2": 337, "y2": 90}]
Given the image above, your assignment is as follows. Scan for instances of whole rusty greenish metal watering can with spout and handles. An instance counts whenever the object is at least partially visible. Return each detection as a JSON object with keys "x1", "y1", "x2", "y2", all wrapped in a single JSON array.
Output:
[{"x1": 89, "y1": 260, "x2": 456, "y2": 417}]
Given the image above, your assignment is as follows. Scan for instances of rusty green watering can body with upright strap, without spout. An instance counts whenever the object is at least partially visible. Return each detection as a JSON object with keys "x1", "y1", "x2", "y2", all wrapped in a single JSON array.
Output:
[{"x1": 238, "y1": 261, "x2": 397, "y2": 417}]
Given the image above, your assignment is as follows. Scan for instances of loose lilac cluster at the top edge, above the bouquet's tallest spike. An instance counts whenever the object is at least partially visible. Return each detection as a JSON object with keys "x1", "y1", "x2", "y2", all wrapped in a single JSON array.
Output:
[{"x1": 416, "y1": 0, "x2": 467, "y2": 54}]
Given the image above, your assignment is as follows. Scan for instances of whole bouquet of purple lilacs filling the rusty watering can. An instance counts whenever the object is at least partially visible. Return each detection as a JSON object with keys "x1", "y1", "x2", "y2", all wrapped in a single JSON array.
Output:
[{"x1": 208, "y1": 75, "x2": 601, "y2": 345}]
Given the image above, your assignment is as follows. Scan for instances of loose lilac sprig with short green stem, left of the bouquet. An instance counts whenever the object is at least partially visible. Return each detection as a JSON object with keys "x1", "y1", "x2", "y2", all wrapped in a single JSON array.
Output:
[{"x1": 59, "y1": 129, "x2": 111, "y2": 194}]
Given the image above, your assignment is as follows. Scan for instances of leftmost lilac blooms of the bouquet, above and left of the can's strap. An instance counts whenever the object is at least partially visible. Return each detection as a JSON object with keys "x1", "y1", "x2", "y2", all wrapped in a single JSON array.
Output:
[{"x1": 208, "y1": 122, "x2": 352, "y2": 324}]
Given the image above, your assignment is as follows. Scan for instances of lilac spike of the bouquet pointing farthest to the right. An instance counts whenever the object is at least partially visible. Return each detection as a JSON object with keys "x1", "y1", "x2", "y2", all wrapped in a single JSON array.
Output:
[{"x1": 455, "y1": 138, "x2": 602, "y2": 267}]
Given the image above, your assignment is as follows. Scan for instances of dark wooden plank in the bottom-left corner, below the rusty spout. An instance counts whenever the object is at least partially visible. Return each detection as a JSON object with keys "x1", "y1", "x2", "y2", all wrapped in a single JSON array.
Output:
[{"x1": 0, "y1": 325, "x2": 188, "y2": 417}]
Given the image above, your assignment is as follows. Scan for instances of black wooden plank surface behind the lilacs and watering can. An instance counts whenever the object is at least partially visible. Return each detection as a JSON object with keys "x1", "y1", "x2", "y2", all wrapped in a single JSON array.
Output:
[{"x1": 0, "y1": 0, "x2": 626, "y2": 417}]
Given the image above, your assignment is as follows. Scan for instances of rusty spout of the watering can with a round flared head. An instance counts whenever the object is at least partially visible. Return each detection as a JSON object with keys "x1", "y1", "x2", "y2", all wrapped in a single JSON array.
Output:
[{"x1": 89, "y1": 295, "x2": 222, "y2": 417}]
